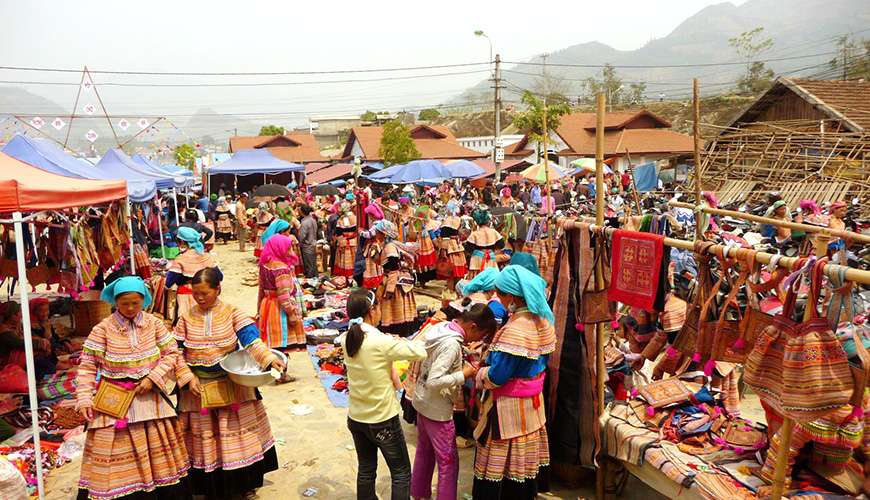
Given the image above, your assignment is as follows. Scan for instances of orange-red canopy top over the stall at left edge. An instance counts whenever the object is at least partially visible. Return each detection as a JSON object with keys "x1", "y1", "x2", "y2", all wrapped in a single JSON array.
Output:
[{"x1": 0, "y1": 153, "x2": 127, "y2": 213}]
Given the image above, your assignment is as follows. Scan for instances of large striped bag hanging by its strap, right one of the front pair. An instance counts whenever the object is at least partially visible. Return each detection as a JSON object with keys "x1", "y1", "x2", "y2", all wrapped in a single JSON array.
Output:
[{"x1": 782, "y1": 259, "x2": 855, "y2": 422}]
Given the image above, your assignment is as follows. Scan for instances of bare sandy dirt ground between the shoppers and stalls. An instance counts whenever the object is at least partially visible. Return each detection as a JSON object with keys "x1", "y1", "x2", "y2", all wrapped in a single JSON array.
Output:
[{"x1": 46, "y1": 244, "x2": 663, "y2": 500}]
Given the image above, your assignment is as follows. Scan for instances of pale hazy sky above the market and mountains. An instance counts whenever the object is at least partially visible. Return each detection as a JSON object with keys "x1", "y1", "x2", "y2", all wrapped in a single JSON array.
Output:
[{"x1": 0, "y1": 0, "x2": 743, "y2": 132}]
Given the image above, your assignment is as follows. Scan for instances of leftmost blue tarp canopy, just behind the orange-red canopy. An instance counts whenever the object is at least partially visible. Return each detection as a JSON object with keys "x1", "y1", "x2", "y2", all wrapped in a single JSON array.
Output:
[{"x1": 3, "y1": 134, "x2": 157, "y2": 203}]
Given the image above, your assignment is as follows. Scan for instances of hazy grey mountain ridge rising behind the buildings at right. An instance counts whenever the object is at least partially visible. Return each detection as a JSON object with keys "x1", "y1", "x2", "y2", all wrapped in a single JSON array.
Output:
[{"x1": 451, "y1": 0, "x2": 870, "y2": 103}]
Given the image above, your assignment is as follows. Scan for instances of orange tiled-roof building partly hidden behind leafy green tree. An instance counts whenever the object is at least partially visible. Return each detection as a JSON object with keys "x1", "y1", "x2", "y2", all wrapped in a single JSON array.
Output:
[{"x1": 341, "y1": 125, "x2": 487, "y2": 162}]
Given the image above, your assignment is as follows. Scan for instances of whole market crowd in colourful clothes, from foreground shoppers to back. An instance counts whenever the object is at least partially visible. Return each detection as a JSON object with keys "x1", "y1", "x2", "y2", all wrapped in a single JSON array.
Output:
[{"x1": 0, "y1": 170, "x2": 849, "y2": 499}]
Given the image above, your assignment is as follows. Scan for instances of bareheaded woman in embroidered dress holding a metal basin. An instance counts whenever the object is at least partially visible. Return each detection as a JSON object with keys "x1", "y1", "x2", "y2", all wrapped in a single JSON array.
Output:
[{"x1": 175, "y1": 269, "x2": 286, "y2": 498}]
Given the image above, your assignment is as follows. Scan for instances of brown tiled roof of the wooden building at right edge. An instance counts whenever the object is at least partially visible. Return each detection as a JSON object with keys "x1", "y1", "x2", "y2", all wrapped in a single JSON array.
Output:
[{"x1": 730, "y1": 77, "x2": 870, "y2": 133}]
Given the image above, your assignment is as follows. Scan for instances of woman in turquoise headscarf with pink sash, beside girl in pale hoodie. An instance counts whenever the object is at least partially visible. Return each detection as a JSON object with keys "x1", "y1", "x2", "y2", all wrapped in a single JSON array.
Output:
[{"x1": 472, "y1": 266, "x2": 556, "y2": 499}]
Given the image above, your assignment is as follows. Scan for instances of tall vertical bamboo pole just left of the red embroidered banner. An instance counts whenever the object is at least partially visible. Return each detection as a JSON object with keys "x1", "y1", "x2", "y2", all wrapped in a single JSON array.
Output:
[{"x1": 595, "y1": 93, "x2": 607, "y2": 500}]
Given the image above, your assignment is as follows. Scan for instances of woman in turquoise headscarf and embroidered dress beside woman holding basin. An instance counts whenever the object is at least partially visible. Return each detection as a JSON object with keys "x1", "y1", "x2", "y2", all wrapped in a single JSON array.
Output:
[{"x1": 76, "y1": 276, "x2": 190, "y2": 500}]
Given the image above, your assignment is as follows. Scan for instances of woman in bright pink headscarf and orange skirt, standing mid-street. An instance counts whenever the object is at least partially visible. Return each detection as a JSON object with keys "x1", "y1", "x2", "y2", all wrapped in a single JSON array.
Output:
[{"x1": 257, "y1": 234, "x2": 305, "y2": 349}]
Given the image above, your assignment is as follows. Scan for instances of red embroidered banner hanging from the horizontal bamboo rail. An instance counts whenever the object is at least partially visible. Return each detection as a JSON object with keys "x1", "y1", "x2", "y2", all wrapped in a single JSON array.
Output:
[{"x1": 607, "y1": 229, "x2": 665, "y2": 311}]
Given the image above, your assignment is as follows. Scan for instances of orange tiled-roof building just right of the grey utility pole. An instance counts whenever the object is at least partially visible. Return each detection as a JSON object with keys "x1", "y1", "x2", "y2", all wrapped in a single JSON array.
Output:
[{"x1": 505, "y1": 110, "x2": 693, "y2": 170}]
